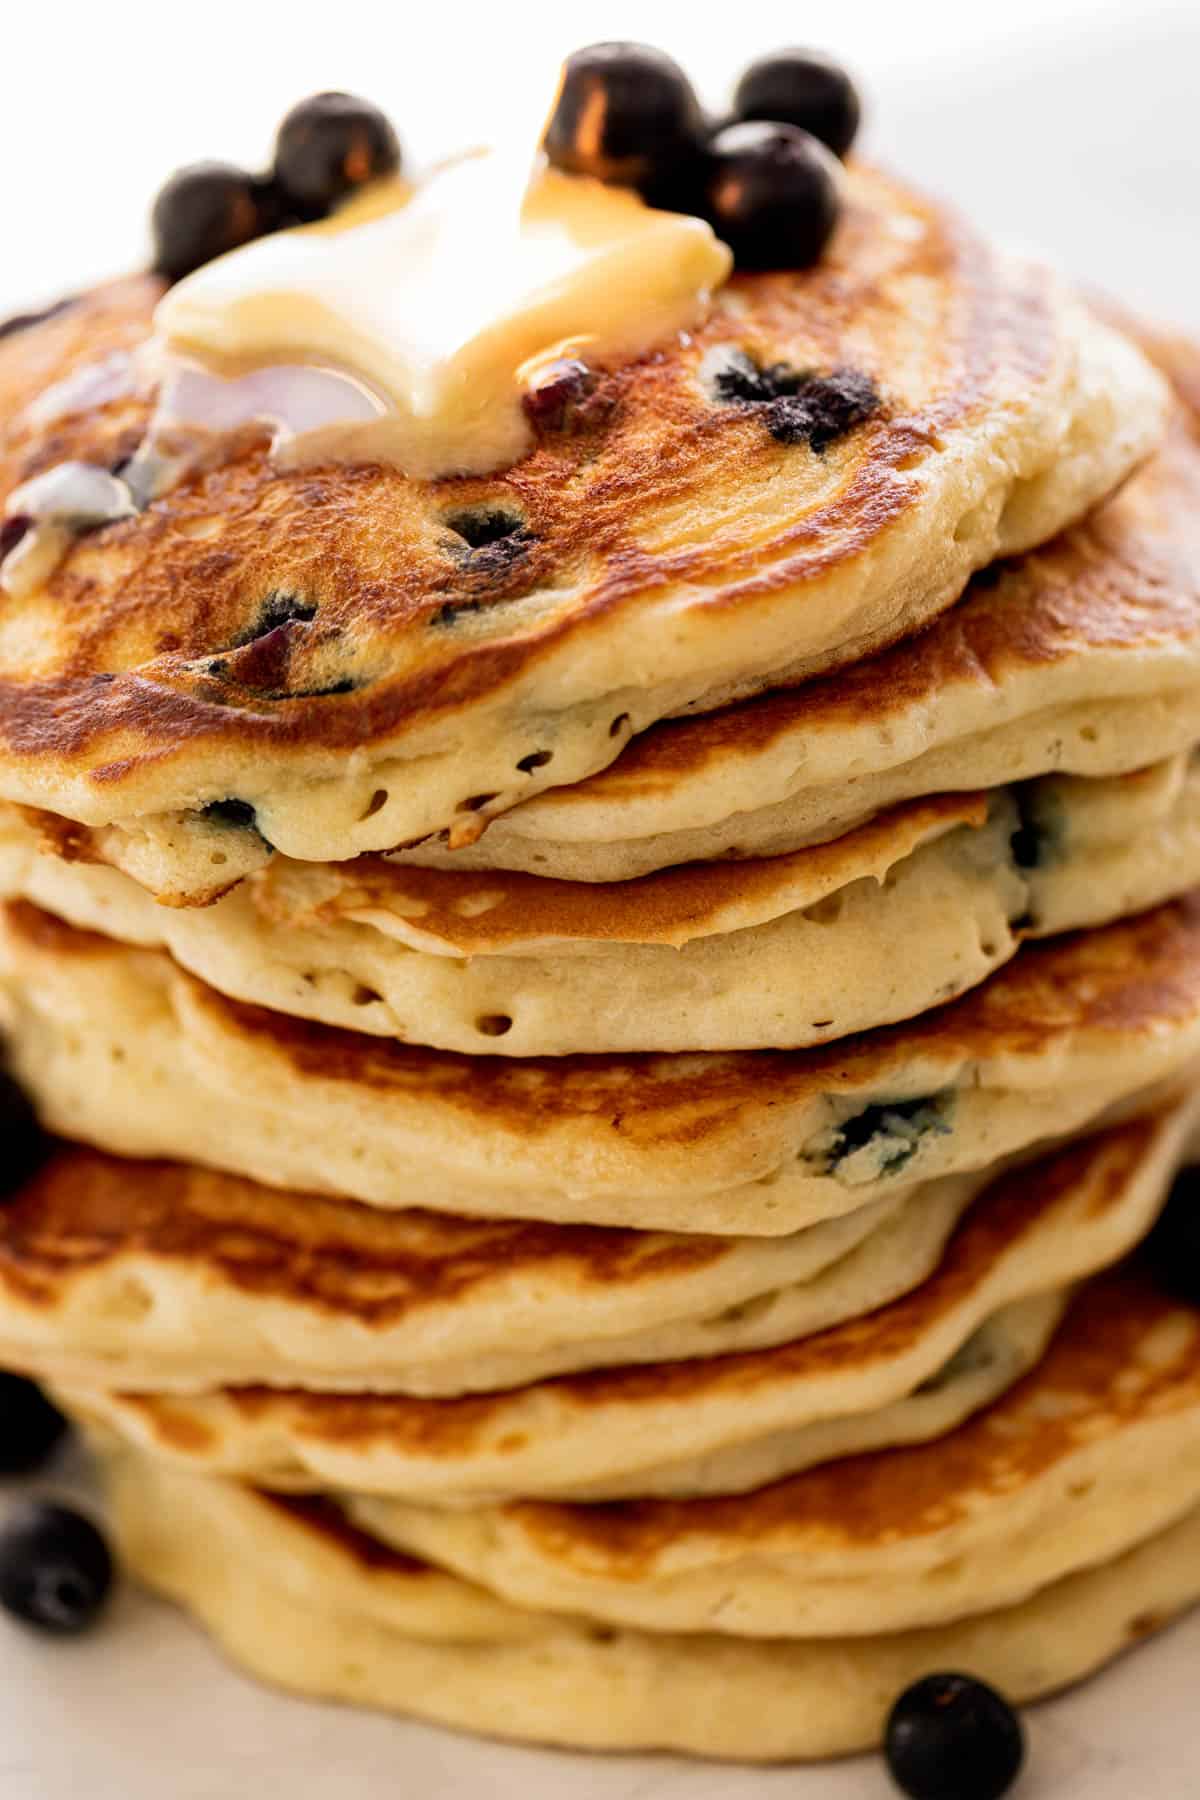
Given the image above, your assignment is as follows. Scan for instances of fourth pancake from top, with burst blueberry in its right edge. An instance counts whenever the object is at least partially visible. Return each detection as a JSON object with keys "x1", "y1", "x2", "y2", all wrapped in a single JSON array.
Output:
[{"x1": 0, "y1": 896, "x2": 1200, "y2": 1237}]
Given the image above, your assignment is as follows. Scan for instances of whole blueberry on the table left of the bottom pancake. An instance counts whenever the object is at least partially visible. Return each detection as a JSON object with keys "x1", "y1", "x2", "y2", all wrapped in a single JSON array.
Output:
[{"x1": 0, "y1": 1499, "x2": 113, "y2": 1636}]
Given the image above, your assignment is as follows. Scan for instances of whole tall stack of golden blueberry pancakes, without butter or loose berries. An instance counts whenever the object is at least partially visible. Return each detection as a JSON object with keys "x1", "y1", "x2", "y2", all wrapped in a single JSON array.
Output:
[{"x1": 0, "y1": 171, "x2": 1200, "y2": 1759}]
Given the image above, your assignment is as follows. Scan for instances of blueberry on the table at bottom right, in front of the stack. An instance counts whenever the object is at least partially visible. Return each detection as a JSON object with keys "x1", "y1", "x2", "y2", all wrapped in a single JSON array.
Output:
[{"x1": 885, "y1": 1674, "x2": 1025, "y2": 1800}]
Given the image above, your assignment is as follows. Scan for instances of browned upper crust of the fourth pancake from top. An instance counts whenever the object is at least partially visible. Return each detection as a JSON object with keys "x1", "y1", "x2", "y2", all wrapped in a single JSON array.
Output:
[{"x1": 4, "y1": 893, "x2": 1200, "y2": 1150}]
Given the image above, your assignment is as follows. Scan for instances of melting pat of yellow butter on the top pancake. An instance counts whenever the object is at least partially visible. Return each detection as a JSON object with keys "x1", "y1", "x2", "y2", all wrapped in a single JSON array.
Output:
[{"x1": 155, "y1": 153, "x2": 732, "y2": 479}]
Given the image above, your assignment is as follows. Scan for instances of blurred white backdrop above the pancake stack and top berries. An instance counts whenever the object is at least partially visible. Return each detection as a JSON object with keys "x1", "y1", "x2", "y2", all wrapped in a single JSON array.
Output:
[{"x1": 0, "y1": 0, "x2": 1200, "y2": 328}]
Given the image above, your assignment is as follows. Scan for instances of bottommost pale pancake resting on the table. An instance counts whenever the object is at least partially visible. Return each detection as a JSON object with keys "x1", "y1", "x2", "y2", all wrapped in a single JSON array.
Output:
[{"x1": 110, "y1": 1456, "x2": 1200, "y2": 1762}]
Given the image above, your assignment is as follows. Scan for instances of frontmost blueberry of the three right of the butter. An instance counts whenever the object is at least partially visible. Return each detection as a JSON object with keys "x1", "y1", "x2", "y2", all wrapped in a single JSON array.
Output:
[{"x1": 705, "y1": 122, "x2": 838, "y2": 268}]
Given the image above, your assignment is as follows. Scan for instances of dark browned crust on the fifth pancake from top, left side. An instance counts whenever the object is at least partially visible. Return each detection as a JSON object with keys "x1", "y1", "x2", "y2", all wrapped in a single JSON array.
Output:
[{"x1": 0, "y1": 1147, "x2": 725, "y2": 1330}]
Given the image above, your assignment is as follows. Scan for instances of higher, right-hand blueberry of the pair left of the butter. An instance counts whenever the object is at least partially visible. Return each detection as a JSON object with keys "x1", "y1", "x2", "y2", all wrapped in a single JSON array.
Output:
[{"x1": 275, "y1": 94, "x2": 401, "y2": 220}]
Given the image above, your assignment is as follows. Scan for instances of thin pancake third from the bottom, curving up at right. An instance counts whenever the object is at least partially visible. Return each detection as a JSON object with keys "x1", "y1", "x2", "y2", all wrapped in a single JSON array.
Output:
[{"x1": 51, "y1": 1094, "x2": 1200, "y2": 1507}]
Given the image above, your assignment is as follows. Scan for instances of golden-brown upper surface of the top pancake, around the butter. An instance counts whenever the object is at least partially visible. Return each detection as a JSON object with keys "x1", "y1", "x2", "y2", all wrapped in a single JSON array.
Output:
[{"x1": 0, "y1": 173, "x2": 1061, "y2": 788}]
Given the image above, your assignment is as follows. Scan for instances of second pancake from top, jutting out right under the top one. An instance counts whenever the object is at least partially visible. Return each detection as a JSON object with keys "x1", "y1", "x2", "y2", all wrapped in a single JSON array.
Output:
[{"x1": 405, "y1": 344, "x2": 1200, "y2": 882}]
